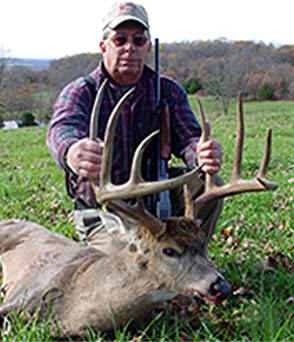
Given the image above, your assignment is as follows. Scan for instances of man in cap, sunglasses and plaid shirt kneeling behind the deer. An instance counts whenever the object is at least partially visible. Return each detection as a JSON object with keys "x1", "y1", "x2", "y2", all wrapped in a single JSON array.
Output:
[{"x1": 47, "y1": 2, "x2": 222, "y2": 253}]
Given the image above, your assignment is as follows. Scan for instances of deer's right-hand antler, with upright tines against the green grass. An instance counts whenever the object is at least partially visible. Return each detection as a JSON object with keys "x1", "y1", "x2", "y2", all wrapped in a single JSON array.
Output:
[{"x1": 194, "y1": 93, "x2": 278, "y2": 211}]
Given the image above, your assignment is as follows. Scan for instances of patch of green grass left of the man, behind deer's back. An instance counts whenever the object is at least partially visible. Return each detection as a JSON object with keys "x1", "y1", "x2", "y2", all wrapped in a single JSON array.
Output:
[{"x1": 0, "y1": 127, "x2": 72, "y2": 235}]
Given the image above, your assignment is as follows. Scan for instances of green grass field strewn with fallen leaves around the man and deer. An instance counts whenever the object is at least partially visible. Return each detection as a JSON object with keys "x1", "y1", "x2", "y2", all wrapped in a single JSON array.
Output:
[{"x1": 0, "y1": 98, "x2": 294, "y2": 342}]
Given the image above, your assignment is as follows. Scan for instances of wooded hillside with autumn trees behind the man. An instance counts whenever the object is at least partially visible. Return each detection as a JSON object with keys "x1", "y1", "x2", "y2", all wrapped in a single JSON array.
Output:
[{"x1": 0, "y1": 39, "x2": 294, "y2": 125}]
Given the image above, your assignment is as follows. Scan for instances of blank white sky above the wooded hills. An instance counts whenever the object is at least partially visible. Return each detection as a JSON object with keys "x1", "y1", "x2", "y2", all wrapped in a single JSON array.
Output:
[{"x1": 0, "y1": 0, "x2": 294, "y2": 59}]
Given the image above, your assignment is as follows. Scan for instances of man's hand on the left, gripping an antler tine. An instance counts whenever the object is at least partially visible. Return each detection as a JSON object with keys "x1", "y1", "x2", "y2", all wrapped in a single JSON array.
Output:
[{"x1": 66, "y1": 138, "x2": 104, "y2": 179}]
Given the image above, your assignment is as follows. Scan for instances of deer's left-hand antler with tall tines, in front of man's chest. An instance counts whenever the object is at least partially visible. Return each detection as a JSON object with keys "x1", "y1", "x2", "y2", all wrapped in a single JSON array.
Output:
[{"x1": 90, "y1": 81, "x2": 201, "y2": 235}]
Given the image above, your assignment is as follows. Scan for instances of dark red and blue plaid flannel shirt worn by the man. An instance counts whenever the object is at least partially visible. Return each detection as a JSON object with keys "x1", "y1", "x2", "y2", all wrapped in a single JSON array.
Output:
[{"x1": 46, "y1": 63, "x2": 201, "y2": 208}]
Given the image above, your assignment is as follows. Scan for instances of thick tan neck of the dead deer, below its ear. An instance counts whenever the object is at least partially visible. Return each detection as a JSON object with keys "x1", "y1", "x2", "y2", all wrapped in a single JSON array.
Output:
[{"x1": 60, "y1": 227, "x2": 176, "y2": 331}]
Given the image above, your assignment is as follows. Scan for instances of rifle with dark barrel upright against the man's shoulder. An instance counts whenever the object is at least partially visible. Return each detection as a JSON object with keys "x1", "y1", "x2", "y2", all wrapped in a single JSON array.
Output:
[{"x1": 155, "y1": 38, "x2": 171, "y2": 219}]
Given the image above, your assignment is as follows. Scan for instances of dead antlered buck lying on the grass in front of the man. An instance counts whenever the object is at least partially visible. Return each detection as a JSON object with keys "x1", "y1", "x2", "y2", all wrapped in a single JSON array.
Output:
[{"x1": 0, "y1": 85, "x2": 277, "y2": 336}]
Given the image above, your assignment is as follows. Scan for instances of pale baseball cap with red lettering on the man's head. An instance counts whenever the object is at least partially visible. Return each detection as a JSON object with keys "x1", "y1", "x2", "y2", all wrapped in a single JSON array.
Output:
[{"x1": 103, "y1": 2, "x2": 149, "y2": 31}]
